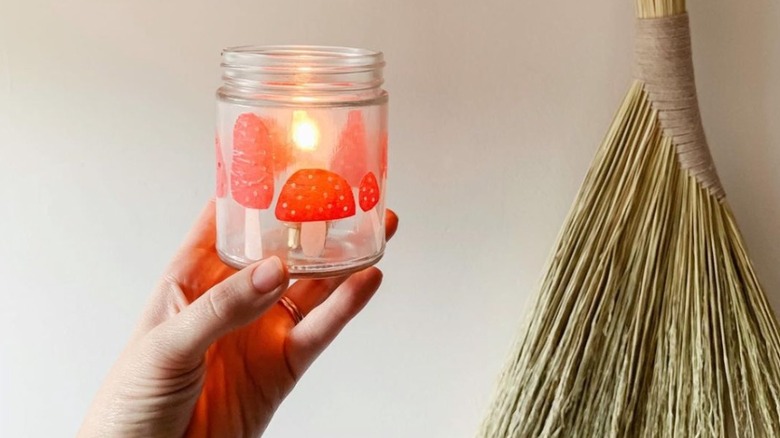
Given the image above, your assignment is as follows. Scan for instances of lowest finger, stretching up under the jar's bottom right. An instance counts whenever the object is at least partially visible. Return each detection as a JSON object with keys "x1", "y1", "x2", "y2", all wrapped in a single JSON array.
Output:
[{"x1": 285, "y1": 268, "x2": 382, "y2": 380}]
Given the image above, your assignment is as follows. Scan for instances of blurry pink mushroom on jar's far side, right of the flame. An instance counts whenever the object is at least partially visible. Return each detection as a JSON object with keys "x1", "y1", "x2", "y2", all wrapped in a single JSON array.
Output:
[{"x1": 330, "y1": 110, "x2": 368, "y2": 187}]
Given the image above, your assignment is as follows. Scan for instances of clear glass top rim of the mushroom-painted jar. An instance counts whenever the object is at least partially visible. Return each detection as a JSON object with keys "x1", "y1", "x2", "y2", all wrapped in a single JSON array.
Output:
[{"x1": 222, "y1": 45, "x2": 385, "y2": 72}]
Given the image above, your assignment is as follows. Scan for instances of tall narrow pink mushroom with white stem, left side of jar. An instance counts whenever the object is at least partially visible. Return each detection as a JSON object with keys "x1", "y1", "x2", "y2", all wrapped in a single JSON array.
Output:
[{"x1": 230, "y1": 113, "x2": 274, "y2": 260}]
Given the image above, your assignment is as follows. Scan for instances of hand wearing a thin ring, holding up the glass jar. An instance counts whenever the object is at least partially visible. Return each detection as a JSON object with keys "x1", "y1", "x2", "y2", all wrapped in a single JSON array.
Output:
[{"x1": 79, "y1": 201, "x2": 398, "y2": 437}]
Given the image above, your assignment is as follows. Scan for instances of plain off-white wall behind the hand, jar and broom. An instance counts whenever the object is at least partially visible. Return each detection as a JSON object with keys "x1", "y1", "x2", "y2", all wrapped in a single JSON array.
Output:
[{"x1": 0, "y1": 0, "x2": 780, "y2": 438}]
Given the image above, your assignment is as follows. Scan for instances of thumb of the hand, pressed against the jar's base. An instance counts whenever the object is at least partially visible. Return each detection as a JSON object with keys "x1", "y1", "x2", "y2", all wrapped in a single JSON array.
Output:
[{"x1": 154, "y1": 257, "x2": 289, "y2": 363}]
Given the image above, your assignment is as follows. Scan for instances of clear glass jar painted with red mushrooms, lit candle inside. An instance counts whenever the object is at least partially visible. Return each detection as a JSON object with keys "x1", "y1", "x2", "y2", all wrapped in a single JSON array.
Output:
[{"x1": 216, "y1": 46, "x2": 388, "y2": 278}]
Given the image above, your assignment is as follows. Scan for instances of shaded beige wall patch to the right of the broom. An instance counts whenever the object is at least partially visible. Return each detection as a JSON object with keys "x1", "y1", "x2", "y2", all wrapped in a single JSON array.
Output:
[{"x1": 691, "y1": 0, "x2": 780, "y2": 308}]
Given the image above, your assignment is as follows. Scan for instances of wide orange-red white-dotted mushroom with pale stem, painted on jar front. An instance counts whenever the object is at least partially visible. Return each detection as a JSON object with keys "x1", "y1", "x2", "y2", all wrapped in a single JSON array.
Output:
[{"x1": 276, "y1": 169, "x2": 355, "y2": 257}]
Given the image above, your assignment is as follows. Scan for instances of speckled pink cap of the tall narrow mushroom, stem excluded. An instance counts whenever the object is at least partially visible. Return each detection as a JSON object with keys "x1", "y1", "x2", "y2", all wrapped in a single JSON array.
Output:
[{"x1": 230, "y1": 113, "x2": 274, "y2": 210}]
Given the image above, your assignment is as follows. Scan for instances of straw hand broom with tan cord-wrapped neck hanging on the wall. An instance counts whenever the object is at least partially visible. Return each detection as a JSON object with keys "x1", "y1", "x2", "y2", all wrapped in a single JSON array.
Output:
[{"x1": 480, "y1": 0, "x2": 780, "y2": 438}]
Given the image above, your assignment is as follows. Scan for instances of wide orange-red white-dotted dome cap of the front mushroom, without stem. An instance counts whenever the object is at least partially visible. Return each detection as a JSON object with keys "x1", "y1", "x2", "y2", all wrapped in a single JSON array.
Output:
[{"x1": 276, "y1": 169, "x2": 355, "y2": 222}]
